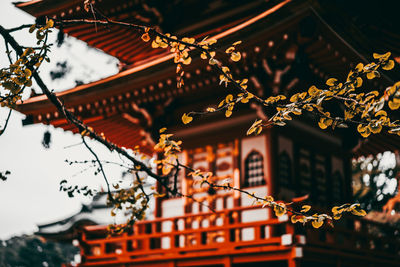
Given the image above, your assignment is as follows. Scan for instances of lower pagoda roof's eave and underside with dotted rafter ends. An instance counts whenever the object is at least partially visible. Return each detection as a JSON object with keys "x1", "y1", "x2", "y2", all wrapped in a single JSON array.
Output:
[{"x1": 14, "y1": 0, "x2": 400, "y2": 155}]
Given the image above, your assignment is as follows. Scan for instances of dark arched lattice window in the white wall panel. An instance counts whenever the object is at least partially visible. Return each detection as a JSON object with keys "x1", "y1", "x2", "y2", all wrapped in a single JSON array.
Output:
[{"x1": 244, "y1": 151, "x2": 265, "y2": 187}]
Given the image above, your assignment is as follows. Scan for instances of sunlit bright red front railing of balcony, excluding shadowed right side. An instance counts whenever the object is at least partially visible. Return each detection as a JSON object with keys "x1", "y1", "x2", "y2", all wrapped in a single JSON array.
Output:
[{"x1": 81, "y1": 206, "x2": 293, "y2": 265}]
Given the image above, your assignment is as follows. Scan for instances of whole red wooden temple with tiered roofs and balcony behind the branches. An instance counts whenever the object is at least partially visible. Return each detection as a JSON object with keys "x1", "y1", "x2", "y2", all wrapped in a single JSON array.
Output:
[{"x1": 16, "y1": 0, "x2": 400, "y2": 267}]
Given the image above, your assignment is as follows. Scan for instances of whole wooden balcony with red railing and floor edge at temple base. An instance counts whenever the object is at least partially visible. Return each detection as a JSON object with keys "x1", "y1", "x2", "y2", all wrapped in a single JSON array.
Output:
[{"x1": 75, "y1": 206, "x2": 400, "y2": 267}]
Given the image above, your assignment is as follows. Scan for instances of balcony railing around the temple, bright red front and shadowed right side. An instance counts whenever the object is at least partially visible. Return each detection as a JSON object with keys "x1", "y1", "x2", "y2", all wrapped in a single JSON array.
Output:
[{"x1": 80, "y1": 206, "x2": 400, "y2": 266}]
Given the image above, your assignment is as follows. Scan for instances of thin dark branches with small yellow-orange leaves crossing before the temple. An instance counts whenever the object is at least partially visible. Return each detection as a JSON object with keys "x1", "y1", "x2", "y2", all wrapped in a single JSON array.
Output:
[{"x1": 0, "y1": 8, "x2": 400, "y2": 234}]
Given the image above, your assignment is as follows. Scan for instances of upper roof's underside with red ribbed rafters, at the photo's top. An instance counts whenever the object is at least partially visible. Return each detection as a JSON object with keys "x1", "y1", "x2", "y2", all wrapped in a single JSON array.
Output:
[{"x1": 16, "y1": 0, "x2": 274, "y2": 66}]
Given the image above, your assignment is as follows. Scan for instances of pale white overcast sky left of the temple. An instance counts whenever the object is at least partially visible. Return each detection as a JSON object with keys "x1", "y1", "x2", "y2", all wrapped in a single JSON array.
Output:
[{"x1": 0, "y1": 0, "x2": 121, "y2": 239}]
